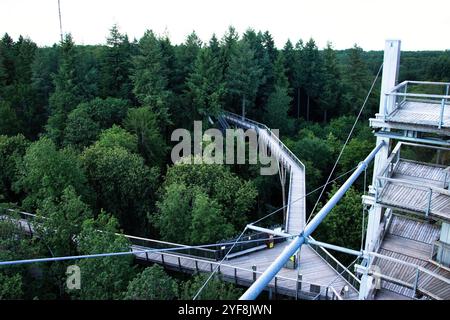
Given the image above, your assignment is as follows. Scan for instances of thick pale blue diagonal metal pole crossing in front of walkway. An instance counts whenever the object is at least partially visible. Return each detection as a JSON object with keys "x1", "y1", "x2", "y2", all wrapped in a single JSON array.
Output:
[{"x1": 239, "y1": 141, "x2": 384, "y2": 300}]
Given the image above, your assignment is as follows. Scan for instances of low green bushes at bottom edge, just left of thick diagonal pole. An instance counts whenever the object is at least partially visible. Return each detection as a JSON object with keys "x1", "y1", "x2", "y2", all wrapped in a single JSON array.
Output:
[{"x1": 181, "y1": 274, "x2": 243, "y2": 300}]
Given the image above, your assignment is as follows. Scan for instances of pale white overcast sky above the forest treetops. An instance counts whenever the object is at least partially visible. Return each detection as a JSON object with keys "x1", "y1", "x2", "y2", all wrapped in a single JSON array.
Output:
[{"x1": 0, "y1": 0, "x2": 450, "y2": 50}]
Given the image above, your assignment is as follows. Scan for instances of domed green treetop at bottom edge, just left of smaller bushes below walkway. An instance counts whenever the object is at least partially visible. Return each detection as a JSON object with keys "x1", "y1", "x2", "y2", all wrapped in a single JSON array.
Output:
[{"x1": 125, "y1": 265, "x2": 178, "y2": 300}]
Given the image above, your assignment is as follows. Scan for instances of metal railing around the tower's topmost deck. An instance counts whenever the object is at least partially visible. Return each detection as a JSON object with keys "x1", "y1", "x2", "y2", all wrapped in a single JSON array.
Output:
[{"x1": 384, "y1": 81, "x2": 450, "y2": 129}]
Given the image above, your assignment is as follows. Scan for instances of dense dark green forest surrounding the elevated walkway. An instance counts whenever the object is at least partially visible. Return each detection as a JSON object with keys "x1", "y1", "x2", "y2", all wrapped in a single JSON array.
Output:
[{"x1": 0, "y1": 26, "x2": 450, "y2": 299}]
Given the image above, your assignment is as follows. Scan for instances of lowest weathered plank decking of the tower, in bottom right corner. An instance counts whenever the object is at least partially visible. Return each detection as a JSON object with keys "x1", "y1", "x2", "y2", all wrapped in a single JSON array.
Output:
[{"x1": 373, "y1": 215, "x2": 450, "y2": 300}]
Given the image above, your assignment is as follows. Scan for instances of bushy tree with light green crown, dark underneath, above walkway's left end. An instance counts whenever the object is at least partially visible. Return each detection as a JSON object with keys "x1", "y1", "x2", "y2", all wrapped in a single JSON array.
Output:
[{"x1": 82, "y1": 139, "x2": 158, "y2": 231}]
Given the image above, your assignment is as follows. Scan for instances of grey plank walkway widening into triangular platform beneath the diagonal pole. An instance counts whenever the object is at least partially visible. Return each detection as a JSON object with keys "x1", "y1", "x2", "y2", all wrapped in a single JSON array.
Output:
[{"x1": 133, "y1": 242, "x2": 358, "y2": 299}]
